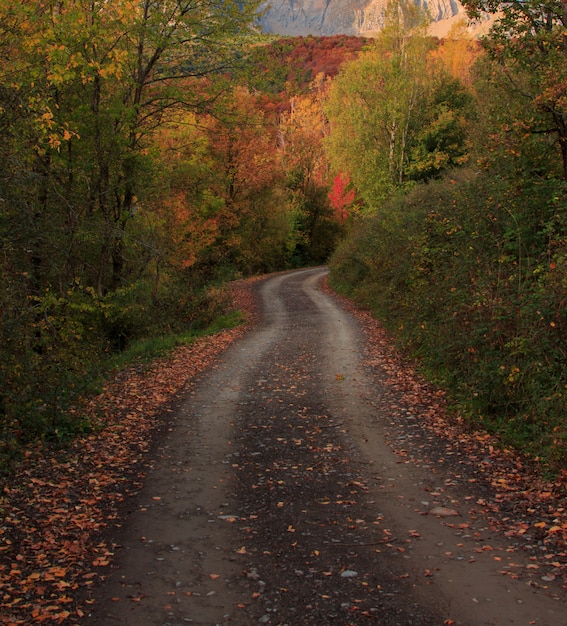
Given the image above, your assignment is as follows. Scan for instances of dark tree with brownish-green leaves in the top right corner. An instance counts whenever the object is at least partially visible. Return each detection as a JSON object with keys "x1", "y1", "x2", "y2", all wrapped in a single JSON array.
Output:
[{"x1": 463, "y1": 0, "x2": 567, "y2": 179}]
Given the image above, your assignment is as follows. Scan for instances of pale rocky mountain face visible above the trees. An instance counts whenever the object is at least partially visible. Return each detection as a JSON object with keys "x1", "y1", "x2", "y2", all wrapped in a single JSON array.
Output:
[{"x1": 261, "y1": 0, "x2": 492, "y2": 37}]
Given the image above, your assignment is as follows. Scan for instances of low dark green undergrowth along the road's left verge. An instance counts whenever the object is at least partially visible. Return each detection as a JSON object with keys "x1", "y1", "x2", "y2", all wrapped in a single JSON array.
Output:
[{"x1": 0, "y1": 276, "x2": 242, "y2": 472}]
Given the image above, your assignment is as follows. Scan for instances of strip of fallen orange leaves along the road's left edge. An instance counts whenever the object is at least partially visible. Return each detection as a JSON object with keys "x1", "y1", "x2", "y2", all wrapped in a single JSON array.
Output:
[{"x1": 0, "y1": 281, "x2": 256, "y2": 626}]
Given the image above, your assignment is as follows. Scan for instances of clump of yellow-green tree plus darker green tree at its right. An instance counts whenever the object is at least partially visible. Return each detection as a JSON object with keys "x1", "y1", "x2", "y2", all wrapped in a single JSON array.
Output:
[{"x1": 326, "y1": 5, "x2": 473, "y2": 211}]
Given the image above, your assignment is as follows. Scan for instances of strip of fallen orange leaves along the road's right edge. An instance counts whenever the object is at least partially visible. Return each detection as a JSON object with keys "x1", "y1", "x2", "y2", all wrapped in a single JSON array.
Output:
[{"x1": 324, "y1": 278, "x2": 567, "y2": 588}]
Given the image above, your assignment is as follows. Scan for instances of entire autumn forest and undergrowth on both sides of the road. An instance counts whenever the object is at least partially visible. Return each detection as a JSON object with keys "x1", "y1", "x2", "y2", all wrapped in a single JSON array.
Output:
[{"x1": 0, "y1": 0, "x2": 567, "y2": 470}]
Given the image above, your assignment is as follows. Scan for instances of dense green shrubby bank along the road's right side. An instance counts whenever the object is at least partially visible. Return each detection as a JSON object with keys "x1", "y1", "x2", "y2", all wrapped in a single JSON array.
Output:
[{"x1": 331, "y1": 171, "x2": 567, "y2": 472}]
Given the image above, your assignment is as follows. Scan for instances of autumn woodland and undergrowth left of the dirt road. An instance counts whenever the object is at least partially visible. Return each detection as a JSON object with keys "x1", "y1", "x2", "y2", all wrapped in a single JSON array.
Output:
[{"x1": 0, "y1": 0, "x2": 363, "y2": 459}]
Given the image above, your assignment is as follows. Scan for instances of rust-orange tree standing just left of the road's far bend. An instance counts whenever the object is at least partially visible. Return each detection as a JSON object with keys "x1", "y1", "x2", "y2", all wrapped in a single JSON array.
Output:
[{"x1": 203, "y1": 87, "x2": 296, "y2": 273}]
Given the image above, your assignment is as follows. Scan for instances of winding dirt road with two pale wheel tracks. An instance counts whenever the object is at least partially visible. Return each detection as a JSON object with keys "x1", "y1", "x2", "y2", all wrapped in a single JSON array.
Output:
[{"x1": 86, "y1": 269, "x2": 567, "y2": 626}]
